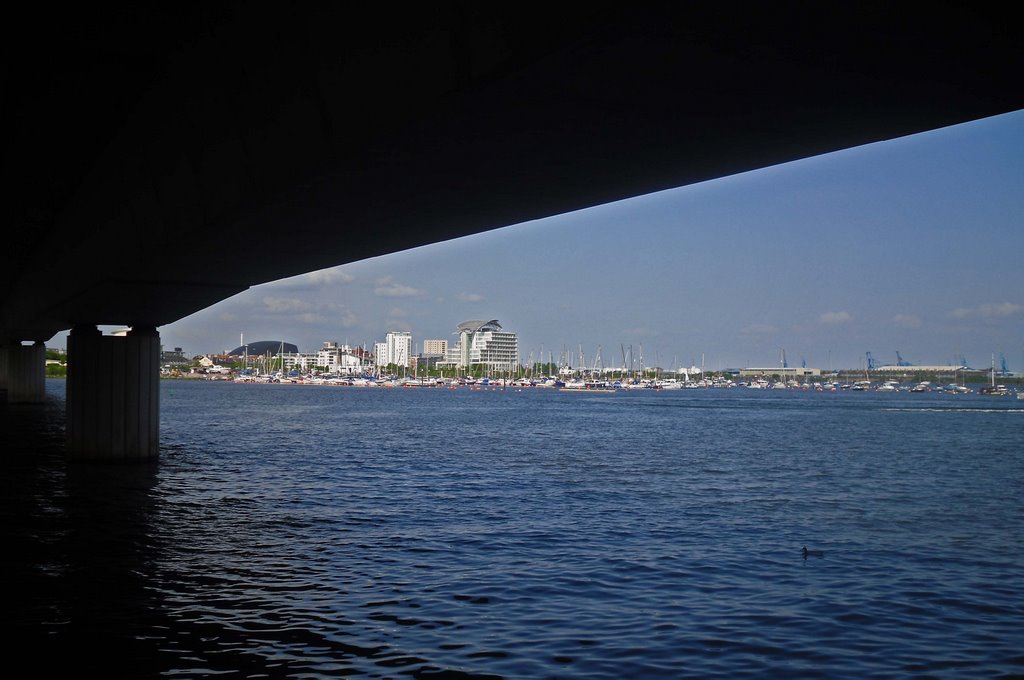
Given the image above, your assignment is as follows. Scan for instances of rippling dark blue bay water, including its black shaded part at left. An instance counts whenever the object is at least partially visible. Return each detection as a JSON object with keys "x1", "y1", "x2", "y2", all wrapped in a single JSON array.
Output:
[{"x1": 2, "y1": 381, "x2": 1024, "y2": 678}]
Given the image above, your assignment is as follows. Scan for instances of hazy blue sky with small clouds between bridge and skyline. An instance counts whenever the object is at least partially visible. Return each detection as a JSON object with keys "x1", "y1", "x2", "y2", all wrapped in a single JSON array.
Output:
[{"x1": 148, "y1": 112, "x2": 1024, "y2": 371}]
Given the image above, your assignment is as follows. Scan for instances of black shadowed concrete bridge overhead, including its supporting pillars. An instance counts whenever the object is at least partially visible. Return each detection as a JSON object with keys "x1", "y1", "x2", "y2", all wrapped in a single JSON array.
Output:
[{"x1": 0, "y1": 1, "x2": 1024, "y2": 459}]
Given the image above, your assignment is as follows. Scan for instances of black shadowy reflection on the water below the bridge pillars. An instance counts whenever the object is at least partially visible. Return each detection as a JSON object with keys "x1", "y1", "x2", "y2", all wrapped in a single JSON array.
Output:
[{"x1": 0, "y1": 395, "x2": 160, "y2": 677}]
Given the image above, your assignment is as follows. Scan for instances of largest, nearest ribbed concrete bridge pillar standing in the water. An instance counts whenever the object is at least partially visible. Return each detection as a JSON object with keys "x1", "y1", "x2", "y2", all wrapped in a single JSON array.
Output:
[{"x1": 68, "y1": 326, "x2": 160, "y2": 461}]
